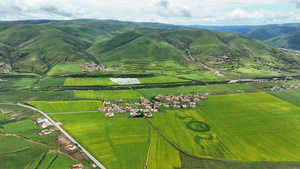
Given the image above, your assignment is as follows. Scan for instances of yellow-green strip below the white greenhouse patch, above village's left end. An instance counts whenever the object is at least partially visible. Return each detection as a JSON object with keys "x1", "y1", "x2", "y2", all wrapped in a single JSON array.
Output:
[{"x1": 74, "y1": 90, "x2": 143, "y2": 100}]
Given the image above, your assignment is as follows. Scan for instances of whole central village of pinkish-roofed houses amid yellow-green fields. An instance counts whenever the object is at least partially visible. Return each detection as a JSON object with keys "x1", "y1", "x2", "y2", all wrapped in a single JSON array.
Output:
[{"x1": 98, "y1": 93, "x2": 209, "y2": 118}]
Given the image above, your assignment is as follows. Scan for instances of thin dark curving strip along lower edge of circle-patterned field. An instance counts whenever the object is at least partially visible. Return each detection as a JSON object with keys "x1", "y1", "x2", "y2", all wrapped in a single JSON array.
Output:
[{"x1": 149, "y1": 121, "x2": 298, "y2": 164}]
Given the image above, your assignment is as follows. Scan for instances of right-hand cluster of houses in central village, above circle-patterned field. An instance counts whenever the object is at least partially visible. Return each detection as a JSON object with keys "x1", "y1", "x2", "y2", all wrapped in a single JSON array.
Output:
[{"x1": 155, "y1": 93, "x2": 209, "y2": 109}]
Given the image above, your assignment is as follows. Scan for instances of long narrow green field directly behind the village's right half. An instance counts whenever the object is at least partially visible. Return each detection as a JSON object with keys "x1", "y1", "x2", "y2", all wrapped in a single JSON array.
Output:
[{"x1": 137, "y1": 84, "x2": 250, "y2": 97}]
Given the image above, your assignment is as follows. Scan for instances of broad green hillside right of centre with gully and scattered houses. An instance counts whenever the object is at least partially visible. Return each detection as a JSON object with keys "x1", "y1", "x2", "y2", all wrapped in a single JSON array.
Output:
[{"x1": 90, "y1": 29, "x2": 299, "y2": 74}]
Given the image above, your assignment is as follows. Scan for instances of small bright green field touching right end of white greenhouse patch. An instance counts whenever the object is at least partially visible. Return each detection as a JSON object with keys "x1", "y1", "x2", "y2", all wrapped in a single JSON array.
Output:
[{"x1": 138, "y1": 76, "x2": 190, "y2": 84}]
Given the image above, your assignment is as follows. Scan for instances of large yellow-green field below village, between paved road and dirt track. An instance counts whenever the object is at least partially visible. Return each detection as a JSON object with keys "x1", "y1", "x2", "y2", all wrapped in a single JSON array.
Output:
[{"x1": 49, "y1": 112, "x2": 150, "y2": 168}]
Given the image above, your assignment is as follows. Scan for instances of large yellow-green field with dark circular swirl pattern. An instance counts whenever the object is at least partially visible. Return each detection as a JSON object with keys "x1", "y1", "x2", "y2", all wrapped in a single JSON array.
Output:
[{"x1": 149, "y1": 93, "x2": 300, "y2": 162}]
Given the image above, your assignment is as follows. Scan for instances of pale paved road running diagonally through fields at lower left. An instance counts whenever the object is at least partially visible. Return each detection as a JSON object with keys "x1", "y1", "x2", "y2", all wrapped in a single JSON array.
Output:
[{"x1": 18, "y1": 103, "x2": 106, "y2": 169}]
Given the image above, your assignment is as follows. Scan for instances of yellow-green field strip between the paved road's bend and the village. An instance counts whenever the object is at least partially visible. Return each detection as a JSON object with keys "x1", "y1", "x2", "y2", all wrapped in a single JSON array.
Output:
[{"x1": 28, "y1": 100, "x2": 103, "y2": 113}]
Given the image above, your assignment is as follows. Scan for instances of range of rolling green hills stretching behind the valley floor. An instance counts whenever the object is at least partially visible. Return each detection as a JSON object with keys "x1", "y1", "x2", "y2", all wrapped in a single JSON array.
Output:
[{"x1": 0, "y1": 20, "x2": 299, "y2": 76}]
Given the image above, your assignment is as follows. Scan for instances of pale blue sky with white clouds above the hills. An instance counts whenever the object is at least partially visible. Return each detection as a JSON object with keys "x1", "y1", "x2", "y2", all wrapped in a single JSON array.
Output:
[{"x1": 0, "y1": 0, "x2": 300, "y2": 26}]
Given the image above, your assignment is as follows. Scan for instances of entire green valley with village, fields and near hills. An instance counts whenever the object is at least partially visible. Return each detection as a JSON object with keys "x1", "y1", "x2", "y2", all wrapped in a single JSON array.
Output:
[{"x1": 0, "y1": 20, "x2": 300, "y2": 169}]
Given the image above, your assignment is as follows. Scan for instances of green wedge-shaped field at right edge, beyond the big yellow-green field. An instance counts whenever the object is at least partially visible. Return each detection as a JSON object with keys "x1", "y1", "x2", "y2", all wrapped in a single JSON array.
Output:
[{"x1": 270, "y1": 90, "x2": 300, "y2": 106}]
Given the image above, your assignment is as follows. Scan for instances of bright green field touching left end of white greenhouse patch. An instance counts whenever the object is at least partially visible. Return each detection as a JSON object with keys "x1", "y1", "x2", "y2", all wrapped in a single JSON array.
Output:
[{"x1": 64, "y1": 78, "x2": 117, "y2": 86}]
